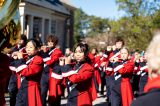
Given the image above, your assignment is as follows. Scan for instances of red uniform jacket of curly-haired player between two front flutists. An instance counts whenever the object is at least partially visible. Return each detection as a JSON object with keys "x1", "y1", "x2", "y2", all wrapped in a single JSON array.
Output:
[{"x1": 46, "y1": 48, "x2": 63, "y2": 102}]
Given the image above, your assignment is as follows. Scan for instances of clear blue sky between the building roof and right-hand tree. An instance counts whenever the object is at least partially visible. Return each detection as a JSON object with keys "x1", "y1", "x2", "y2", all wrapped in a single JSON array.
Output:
[{"x1": 70, "y1": 0, "x2": 124, "y2": 19}]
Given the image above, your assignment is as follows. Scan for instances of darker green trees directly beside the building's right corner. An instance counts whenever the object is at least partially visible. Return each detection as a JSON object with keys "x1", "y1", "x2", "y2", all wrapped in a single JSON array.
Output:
[{"x1": 74, "y1": 9, "x2": 109, "y2": 43}]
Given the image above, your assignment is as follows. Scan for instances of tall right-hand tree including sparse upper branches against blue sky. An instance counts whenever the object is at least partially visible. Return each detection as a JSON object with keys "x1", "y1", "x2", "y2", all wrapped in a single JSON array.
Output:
[{"x1": 110, "y1": 0, "x2": 159, "y2": 50}]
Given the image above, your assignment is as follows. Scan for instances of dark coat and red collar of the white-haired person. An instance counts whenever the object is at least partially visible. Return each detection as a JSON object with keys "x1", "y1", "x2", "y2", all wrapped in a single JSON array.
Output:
[{"x1": 131, "y1": 76, "x2": 160, "y2": 106}]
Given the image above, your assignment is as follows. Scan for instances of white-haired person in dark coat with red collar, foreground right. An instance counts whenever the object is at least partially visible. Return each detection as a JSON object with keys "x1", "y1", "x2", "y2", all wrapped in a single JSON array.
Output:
[{"x1": 131, "y1": 33, "x2": 160, "y2": 106}]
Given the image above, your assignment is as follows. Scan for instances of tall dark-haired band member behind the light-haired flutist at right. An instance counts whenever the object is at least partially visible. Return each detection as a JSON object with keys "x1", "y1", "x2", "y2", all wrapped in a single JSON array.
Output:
[{"x1": 104, "y1": 38, "x2": 124, "y2": 102}]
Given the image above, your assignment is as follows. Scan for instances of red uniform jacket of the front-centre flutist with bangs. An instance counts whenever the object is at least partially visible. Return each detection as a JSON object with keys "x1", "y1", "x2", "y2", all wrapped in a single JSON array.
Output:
[{"x1": 62, "y1": 63, "x2": 97, "y2": 106}]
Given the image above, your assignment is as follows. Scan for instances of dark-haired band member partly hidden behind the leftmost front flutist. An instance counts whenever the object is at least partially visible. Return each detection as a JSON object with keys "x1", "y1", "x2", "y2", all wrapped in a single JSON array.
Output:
[{"x1": 8, "y1": 34, "x2": 27, "y2": 106}]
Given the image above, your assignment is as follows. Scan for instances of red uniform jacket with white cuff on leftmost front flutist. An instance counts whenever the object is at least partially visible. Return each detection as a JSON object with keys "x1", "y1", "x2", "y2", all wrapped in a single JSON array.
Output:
[{"x1": 16, "y1": 56, "x2": 43, "y2": 106}]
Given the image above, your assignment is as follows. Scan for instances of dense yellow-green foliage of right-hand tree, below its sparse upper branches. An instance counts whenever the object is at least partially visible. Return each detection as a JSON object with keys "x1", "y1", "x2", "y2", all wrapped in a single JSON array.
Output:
[{"x1": 111, "y1": 16, "x2": 152, "y2": 50}]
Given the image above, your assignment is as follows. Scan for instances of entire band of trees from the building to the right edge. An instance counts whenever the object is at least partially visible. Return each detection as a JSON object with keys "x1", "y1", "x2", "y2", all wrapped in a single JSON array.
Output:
[{"x1": 75, "y1": 0, "x2": 160, "y2": 50}]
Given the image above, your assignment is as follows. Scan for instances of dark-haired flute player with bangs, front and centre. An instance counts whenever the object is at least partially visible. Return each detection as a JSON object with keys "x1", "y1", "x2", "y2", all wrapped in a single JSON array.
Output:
[{"x1": 60, "y1": 43, "x2": 97, "y2": 106}]
